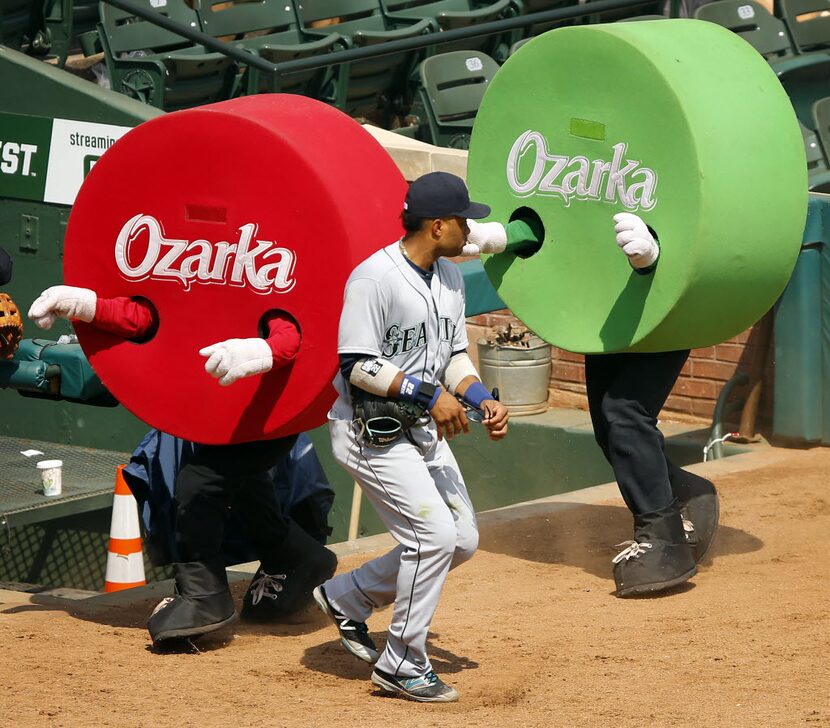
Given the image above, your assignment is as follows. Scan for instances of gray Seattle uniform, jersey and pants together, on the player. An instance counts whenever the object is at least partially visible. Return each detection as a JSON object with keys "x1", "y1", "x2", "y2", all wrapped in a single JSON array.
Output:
[{"x1": 325, "y1": 237, "x2": 478, "y2": 677}]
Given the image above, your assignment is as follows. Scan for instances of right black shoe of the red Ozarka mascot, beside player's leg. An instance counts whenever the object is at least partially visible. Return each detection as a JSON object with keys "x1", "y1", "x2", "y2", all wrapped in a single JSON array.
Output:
[{"x1": 242, "y1": 521, "x2": 337, "y2": 623}]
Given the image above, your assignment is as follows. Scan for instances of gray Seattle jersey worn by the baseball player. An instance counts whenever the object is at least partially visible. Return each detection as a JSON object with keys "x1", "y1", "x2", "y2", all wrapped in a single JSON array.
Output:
[{"x1": 329, "y1": 242, "x2": 467, "y2": 420}]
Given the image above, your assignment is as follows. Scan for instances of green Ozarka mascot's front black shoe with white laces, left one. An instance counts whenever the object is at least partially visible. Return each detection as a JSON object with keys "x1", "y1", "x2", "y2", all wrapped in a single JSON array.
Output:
[{"x1": 612, "y1": 500, "x2": 697, "y2": 597}]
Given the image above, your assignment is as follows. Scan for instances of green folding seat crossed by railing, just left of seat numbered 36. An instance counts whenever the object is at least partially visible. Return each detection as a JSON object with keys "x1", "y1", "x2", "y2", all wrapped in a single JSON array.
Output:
[{"x1": 296, "y1": 0, "x2": 432, "y2": 121}]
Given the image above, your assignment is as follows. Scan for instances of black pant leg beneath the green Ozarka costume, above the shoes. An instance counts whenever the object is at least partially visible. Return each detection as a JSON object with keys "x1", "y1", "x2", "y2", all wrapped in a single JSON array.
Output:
[{"x1": 585, "y1": 349, "x2": 689, "y2": 516}]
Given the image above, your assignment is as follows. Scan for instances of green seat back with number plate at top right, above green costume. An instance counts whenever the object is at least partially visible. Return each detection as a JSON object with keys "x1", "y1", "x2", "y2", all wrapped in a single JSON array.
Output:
[{"x1": 694, "y1": 0, "x2": 793, "y2": 61}]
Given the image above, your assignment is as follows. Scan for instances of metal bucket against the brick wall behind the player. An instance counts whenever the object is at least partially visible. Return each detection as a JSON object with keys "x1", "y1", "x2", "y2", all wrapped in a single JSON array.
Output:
[{"x1": 476, "y1": 336, "x2": 550, "y2": 416}]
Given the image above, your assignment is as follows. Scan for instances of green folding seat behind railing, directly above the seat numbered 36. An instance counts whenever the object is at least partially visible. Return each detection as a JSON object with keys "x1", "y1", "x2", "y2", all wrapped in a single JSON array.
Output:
[{"x1": 381, "y1": 0, "x2": 522, "y2": 58}]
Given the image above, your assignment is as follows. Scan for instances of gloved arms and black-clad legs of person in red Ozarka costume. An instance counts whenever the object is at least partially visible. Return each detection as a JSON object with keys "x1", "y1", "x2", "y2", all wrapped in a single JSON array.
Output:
[{"x1": 29, "y1": 286, "x2": 337, "y2": 644}]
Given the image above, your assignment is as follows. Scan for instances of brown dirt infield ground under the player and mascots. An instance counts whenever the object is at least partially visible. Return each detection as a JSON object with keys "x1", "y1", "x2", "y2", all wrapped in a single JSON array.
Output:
[{"x1": 0, "y1": 448, "x2": 830, "y2": 728}]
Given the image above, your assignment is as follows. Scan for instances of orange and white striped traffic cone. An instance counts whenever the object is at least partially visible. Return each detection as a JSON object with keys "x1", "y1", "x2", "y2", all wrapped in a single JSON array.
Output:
[{"x1": 104, "y1": 465, "x2": 147, "y2": 592}]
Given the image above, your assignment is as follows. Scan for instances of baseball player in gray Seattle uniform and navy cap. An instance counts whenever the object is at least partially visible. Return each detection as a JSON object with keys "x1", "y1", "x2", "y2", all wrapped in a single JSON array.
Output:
[{"x1": 314, "y1": 172, "x2": 508, "y2": 702}]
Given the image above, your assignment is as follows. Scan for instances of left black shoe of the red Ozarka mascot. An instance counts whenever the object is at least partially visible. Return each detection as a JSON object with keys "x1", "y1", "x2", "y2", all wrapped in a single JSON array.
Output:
[{"x1": 147, "y1": 561, "x2": 237, "y2": 645}]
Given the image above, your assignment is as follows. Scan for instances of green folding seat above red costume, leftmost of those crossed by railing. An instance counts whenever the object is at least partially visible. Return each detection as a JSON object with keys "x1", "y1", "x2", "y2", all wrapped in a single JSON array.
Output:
[{"x1": 98, "y1": 0, "x2": 237, "y2": 111}]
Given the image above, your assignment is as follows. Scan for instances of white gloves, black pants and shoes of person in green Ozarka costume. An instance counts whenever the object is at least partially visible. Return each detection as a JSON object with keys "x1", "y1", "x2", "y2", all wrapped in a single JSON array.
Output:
[{"x1": 464, "y1": 212, "x2": 719, "y2": 597}]
